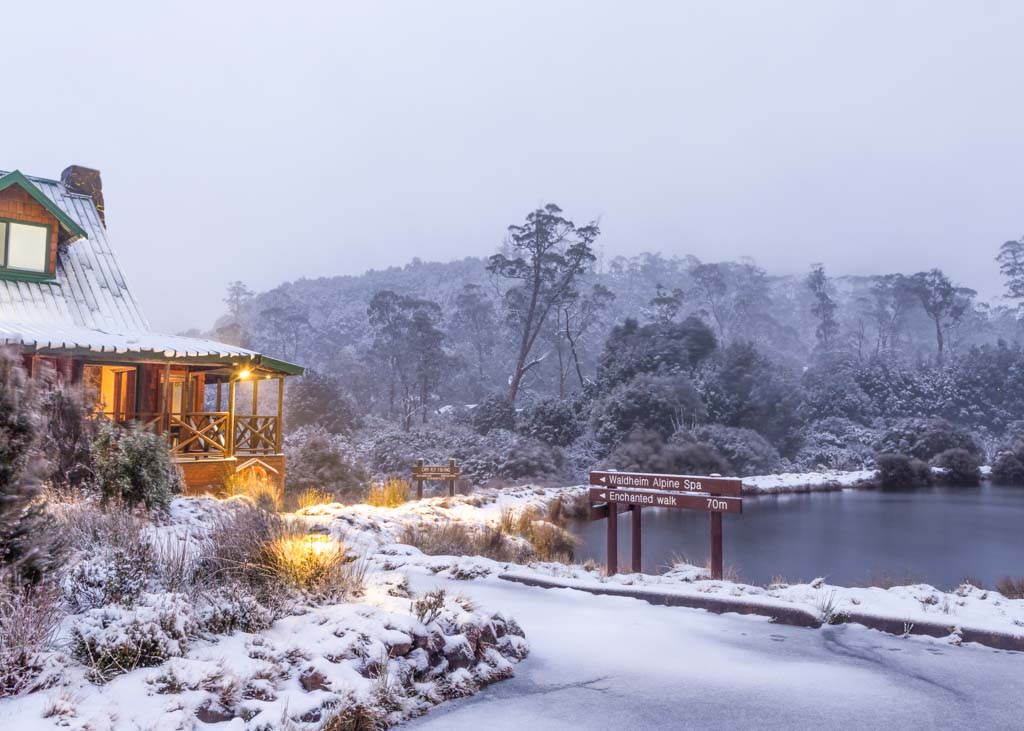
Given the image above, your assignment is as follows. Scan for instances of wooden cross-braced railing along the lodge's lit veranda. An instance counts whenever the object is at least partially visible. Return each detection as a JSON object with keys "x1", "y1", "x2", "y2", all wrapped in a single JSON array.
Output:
[{"x1": 95, "y1": 412, "x2": 281, "y2": 460}]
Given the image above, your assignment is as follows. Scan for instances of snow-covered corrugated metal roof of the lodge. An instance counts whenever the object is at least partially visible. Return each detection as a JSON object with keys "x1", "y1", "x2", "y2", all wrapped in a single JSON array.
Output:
[{"x1": 0, "y1": 166, "x2": 301, "y2": 371}]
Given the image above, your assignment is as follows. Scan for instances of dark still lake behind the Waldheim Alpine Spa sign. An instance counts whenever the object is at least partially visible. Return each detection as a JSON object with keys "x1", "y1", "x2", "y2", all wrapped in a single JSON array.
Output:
[{"x1": 572, "y1": 484, "x2": 1024, "y2": 589}]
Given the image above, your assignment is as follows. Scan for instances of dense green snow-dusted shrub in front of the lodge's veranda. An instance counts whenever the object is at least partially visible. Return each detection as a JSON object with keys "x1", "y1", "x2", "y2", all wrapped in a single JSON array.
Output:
[{"x1": 93, "y1": 423, "x2": 183, "y2": 510}]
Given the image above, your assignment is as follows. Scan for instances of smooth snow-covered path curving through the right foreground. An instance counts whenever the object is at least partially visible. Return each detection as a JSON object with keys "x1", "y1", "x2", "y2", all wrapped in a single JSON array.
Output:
[{"x1": 410, "y1": 576, "x2": 1024, "y2": 731}]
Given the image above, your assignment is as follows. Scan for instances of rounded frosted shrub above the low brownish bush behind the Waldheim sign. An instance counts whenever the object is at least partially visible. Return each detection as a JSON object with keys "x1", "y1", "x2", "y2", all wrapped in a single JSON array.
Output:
[{"x1": 593, "y1": 374, "x2": 703, "y2": 447}]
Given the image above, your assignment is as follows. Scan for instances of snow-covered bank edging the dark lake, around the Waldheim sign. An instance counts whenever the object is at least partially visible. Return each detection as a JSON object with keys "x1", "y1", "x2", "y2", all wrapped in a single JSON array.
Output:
[{"x1": 301, "y1": 473, "x2": 1024, "y2": 647}]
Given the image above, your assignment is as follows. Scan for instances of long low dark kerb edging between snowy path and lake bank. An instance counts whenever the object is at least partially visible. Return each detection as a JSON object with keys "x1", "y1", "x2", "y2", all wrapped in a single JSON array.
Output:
[{"x1": 499, "y1": 573, "x2": 1024, "y2": 652}]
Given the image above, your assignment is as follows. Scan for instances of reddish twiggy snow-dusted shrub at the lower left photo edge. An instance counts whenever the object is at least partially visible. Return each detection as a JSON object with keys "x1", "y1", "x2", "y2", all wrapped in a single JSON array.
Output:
[{"x1": 0, "y1": 576, "x2": 62, "y2": 697}]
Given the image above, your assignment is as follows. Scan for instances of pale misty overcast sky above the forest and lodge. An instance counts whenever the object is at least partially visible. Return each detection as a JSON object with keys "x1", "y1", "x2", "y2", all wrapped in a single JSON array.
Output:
[{"x1": 0, "y1": 1, "x2": 1024, "y2": 331}]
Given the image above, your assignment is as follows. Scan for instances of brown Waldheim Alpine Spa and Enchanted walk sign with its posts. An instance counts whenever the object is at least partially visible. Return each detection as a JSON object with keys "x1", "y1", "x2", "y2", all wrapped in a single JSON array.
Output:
[{"x1": 590, "y1": 471, "x2": 743, "y2": 578}]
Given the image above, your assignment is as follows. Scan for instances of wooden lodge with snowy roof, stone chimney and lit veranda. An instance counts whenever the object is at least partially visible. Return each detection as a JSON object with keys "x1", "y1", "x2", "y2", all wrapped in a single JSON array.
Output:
[{"x1": 0, "y1": 166, "x2": 302, "y2": 491}]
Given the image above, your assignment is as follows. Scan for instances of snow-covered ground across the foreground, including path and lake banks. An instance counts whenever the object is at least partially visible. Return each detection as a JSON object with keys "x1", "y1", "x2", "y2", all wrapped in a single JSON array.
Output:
[{"x1": 0, "y1": 473, "x2": 1024, "y2": 731}]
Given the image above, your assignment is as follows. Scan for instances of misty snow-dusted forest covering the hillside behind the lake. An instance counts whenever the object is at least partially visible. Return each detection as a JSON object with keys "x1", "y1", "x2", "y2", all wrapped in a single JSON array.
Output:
[{"x1": 193, "y1": 204, "x2": 1024, "y2": 495}]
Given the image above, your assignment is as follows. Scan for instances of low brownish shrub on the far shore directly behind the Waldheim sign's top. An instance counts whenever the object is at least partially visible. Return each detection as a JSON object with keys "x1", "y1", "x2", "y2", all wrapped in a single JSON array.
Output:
[{"x1": 605, "y1": 430, "x2": 732, "y2": 475}]
